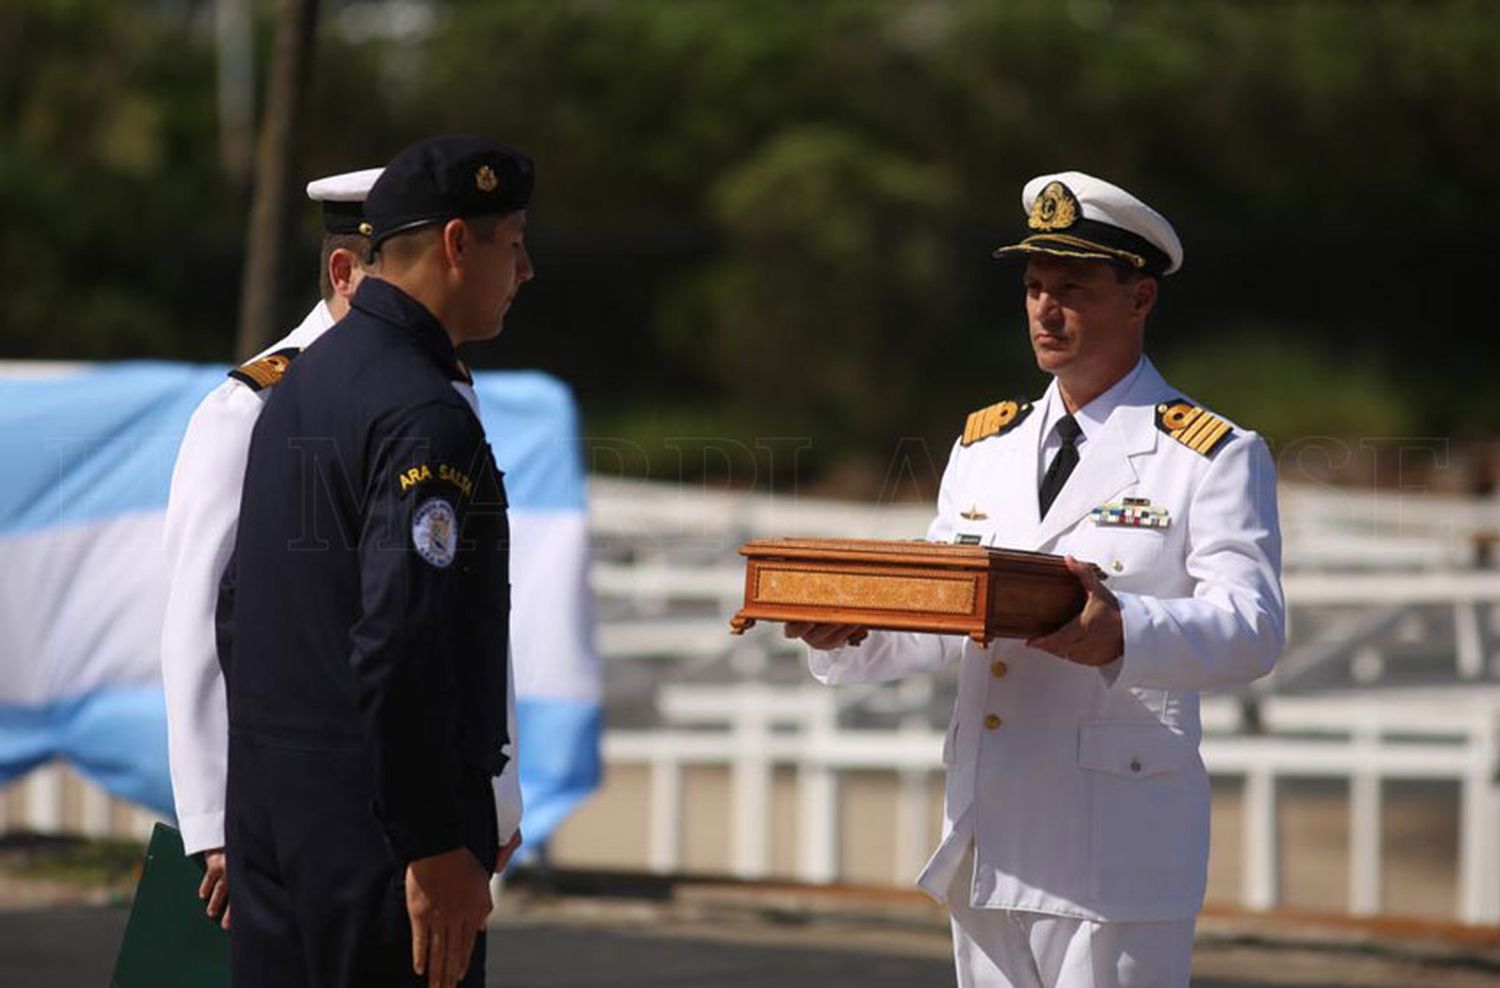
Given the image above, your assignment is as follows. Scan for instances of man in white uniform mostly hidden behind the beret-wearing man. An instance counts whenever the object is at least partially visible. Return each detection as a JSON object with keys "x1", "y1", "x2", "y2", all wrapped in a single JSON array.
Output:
[{"x1": 162, "y1": 168, "x2": 522, "y2": 928}]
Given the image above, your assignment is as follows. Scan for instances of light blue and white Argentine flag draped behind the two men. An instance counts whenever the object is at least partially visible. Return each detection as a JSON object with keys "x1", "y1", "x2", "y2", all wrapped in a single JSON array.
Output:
[{"x1": 0, "y1": 361, "x2": 602, "y2": 846}]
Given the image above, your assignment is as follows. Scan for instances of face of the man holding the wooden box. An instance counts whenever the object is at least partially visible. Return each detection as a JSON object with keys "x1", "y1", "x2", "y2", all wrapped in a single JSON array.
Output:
[{"x1": 1025, "y1": 255, "x2": 1155, "y2": 376}]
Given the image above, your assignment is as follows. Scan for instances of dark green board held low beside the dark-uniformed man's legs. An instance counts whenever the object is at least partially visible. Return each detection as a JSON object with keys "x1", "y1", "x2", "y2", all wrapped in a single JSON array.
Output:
[{"x1": 110, "y1": 823, "x2": 230, "y2": 988}]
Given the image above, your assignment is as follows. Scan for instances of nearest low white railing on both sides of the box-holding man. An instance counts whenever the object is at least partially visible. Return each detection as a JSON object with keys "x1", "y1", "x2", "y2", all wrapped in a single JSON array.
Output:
[{"x1": 605, "y1": 684, "x2": 1500, "y2": 924}]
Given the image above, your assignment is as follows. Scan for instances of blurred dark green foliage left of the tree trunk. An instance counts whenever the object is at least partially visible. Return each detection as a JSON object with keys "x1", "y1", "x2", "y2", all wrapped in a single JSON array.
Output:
[{"x1": 0, "y1": 0, "x2": 243, "y2": 358}]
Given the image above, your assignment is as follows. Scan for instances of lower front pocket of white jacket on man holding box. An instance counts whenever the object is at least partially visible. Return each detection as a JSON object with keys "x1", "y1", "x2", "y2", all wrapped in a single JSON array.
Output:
[{"x1": 1079, "y1": 724, "x2": 1209, "y2": 909}]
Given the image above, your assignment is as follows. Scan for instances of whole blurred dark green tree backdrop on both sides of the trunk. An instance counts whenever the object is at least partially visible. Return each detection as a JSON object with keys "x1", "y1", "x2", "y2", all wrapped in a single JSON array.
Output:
[{"x1": 0, "y1": 0, "x2": 1500, "y2": 485}]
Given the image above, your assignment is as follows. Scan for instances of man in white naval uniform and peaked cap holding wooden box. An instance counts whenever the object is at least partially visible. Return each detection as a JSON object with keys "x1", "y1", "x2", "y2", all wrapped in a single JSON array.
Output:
[{"x1": 786, "y1": 172, "x2": 1286, "y2": 988}]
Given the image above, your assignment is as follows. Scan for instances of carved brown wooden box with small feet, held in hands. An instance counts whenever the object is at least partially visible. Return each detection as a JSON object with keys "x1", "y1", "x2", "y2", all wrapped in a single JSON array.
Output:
[{"x1": 729, "y1": 538, "x2": 1085, "y2": 643}]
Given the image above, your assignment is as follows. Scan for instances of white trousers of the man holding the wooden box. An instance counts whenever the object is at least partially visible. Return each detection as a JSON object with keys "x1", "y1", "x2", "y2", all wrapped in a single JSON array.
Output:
[{"x1": 948, "y1": 846, "x2": 1194, "y2": 988}]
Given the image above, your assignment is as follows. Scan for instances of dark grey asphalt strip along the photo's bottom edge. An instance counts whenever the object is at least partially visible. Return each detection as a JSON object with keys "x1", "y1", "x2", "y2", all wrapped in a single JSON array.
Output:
[{"x1": 0, "y1": 901, "x2": 1500, "y2": 988}]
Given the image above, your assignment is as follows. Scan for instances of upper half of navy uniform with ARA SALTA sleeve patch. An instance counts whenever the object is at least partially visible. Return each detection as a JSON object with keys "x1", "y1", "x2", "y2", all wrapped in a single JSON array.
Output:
[{"x1": 224, "y1": 279, "x2": 510, "y2": 867}]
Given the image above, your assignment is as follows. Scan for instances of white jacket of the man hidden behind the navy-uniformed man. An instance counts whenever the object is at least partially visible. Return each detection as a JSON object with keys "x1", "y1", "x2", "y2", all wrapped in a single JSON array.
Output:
[{"x1": 162, "y1": 301, "x2": 522, "y2": 855}]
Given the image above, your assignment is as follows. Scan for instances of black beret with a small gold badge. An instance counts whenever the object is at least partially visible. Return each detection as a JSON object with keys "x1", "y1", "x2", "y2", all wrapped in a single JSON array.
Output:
[{"x1": 365, "y1": 136, "x2": 536, "y2": 247}]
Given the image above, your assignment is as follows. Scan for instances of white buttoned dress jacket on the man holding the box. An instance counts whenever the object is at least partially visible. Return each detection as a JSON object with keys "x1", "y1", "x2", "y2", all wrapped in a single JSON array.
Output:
[{"x1": 809, "y1": 358, "x2": 1286, "y2": 922}]
